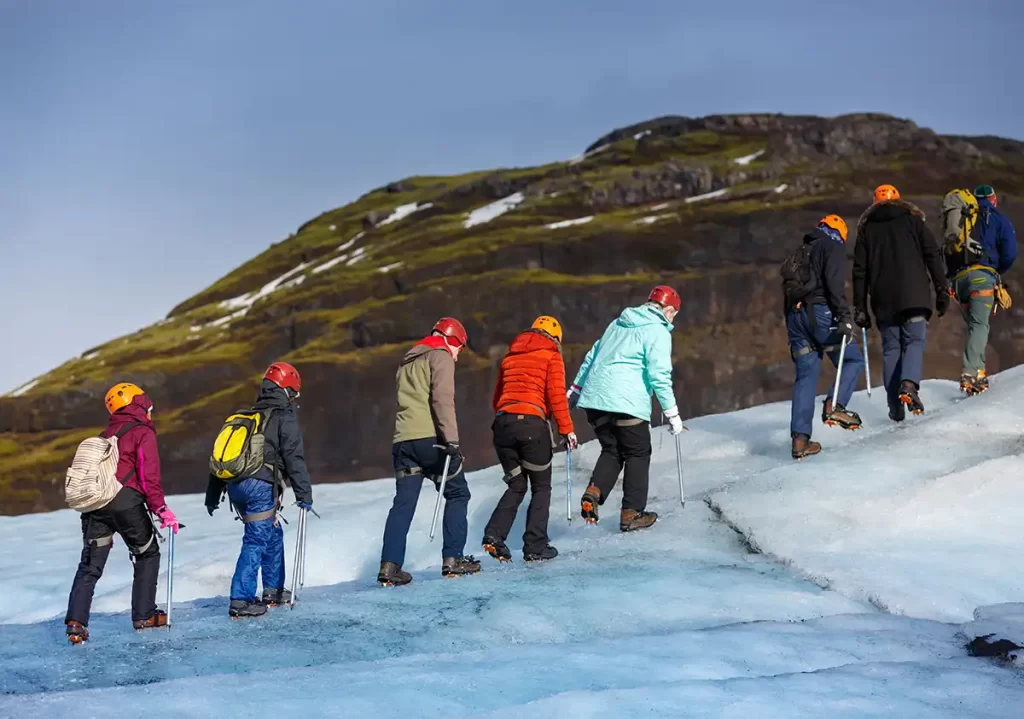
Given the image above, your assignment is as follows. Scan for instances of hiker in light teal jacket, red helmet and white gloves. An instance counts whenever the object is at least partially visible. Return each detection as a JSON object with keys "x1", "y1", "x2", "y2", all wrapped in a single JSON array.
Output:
[{"x1": 567, "y1": 285, "x2": 683, "y2": 532}]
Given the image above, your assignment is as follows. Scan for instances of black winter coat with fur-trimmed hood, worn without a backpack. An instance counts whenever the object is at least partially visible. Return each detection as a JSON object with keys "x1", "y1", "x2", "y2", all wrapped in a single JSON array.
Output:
[{"x1": 853, "y1": 200, "x2": 947, "y2": 325}]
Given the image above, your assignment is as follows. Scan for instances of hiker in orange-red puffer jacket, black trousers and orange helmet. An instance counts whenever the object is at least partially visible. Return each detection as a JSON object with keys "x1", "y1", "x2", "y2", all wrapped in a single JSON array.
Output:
[{"x1": 483, "y1": 315, "x2": 578, "y2": 561}]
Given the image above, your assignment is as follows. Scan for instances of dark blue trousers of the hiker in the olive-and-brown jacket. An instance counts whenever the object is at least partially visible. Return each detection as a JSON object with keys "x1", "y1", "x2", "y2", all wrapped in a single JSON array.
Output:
[{"x1": 381, "y1": 437, "x2": 469, "y2": 566}]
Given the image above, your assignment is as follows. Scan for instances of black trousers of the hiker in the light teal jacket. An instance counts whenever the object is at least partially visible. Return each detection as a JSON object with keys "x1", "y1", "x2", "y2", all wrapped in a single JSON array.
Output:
[{"x1": 587, "y1": 410, "x2": 650, "y2": 512}]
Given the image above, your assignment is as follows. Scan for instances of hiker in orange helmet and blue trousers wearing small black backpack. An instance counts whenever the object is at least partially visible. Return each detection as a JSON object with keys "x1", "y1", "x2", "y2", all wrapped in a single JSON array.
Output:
[{"x1": 782, "y1": 215, "x2": 864, "y2": 460}]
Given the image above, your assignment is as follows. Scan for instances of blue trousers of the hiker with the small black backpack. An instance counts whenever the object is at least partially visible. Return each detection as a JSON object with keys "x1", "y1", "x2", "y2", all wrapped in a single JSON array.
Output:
[{"x1": 785, "y1": 304, "x2": 864, "y2": 436}]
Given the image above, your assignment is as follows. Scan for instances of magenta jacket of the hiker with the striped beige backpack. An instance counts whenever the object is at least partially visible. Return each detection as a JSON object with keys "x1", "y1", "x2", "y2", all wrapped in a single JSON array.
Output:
[{"x1": 103, "y1": 394, "x2": 167, "y2": 514}]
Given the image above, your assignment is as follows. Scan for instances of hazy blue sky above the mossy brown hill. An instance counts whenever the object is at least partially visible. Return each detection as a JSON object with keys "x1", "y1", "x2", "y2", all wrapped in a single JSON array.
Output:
[{"x1": 0, "y1": 0, "x2": 1024, "y2": 391}]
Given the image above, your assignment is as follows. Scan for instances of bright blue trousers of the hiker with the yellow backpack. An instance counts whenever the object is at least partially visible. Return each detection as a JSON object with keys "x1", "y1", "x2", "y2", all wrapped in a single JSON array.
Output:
[{"x1": 227, "y1": 478, "x2": 285, "y2": 601}]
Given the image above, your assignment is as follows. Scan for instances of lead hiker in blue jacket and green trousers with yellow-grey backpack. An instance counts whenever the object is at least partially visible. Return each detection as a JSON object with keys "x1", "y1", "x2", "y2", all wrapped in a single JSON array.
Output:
[{"x1": 943, "y1": 184, "x2": 1017, "y2": 396}]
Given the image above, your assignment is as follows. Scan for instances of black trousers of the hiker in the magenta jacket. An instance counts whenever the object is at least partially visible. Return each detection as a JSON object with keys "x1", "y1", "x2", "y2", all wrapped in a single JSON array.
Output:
[{"x1": 65, "y1": 487, "x2": 160, "y2": 627}]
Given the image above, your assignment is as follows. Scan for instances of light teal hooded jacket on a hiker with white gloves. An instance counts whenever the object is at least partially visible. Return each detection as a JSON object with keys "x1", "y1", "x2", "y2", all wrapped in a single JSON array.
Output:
[{"x1": 573, "y1": 304, "x2": 676, "y2": 422}]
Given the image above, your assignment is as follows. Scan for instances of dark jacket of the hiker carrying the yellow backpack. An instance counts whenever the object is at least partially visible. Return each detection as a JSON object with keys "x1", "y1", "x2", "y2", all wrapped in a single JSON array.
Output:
[{"x1": 206, "y1": 380, "x2": 313, "y2": 507}]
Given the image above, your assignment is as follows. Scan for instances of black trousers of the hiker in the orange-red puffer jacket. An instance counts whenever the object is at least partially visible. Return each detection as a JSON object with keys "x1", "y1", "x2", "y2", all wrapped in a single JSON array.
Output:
[{"x1": 483, "y1": 415, "x2": 552, "y2": 554}]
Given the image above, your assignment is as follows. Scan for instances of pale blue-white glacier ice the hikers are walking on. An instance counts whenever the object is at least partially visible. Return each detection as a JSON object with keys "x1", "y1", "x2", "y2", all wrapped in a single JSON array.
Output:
[{"x1": 0, "y1": 370, "x2": 1024, "y2": 719}]
